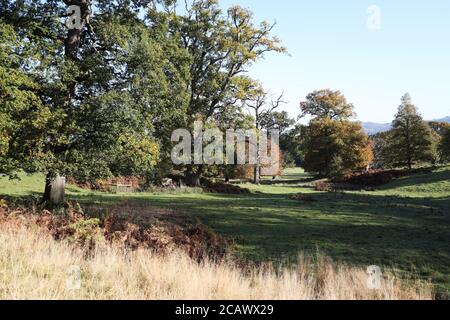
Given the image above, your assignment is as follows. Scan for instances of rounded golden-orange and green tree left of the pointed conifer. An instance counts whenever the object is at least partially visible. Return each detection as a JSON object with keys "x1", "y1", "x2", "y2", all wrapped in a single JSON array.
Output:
[{"x1": 300, "y1": 90, "x2": 372, "y2": 178}]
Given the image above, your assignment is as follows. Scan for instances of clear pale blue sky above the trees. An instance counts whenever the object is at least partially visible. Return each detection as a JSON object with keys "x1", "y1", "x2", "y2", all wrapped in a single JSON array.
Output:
[{"x1": 220, "y1": 0, "x2": 450, "y2": 122}]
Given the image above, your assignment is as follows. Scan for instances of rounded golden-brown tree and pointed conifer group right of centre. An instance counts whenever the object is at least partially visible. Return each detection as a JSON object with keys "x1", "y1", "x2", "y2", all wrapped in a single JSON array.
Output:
[{"x1": 281, "y1": 90, "x2": 450, "y2": 178}]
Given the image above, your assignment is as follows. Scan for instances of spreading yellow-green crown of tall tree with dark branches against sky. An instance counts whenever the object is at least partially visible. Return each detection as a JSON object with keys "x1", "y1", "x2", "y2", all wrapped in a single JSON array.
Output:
[{"x1": 167, "y1": 0, "x2": 285, "y2": 186}]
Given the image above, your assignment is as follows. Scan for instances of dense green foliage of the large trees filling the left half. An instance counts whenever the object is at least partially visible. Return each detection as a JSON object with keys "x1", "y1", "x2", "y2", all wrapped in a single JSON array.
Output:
[{"x1": 0, "y1": 0, "x2": 285, "y2": 189}]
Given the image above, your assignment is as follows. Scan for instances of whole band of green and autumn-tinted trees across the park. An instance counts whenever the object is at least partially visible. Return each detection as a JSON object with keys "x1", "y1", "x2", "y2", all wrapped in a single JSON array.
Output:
[{"x1": 0, "y1": 0, "x2": 450, "y2": 205}]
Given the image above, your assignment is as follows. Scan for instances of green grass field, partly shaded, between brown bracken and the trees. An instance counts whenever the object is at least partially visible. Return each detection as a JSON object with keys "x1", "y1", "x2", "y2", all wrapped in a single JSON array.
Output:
[{"x1": 0, "y1": 167, "x2": 450, "y2": 296}]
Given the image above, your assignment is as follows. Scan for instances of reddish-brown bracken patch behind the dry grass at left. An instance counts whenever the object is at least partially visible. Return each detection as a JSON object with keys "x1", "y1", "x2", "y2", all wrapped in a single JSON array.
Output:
[{"x1": 0, "y1": 203, "x2": 232, "y2": 261}]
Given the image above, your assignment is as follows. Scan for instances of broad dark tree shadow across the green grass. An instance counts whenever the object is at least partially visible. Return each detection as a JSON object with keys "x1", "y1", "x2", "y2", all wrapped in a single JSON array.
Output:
[{"x1": 67, "y1": 193, "x2": 450, "y2": 265}]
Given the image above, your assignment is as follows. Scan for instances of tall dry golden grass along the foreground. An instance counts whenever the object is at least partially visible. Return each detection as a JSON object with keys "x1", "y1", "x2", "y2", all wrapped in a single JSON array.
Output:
[{"x1": 0, "y1": 218, "x2": 432, "y2": 300}]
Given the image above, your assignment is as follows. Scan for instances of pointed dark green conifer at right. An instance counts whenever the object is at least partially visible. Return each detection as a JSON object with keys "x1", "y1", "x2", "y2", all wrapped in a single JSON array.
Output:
[{"x1": 387, "y1": 94, "x2": 433, "y2": 170}]
